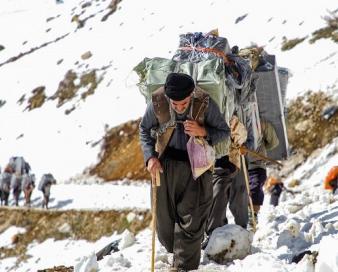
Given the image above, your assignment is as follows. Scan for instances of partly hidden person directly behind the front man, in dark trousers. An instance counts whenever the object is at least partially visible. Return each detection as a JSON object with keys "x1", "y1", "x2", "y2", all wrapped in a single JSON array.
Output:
[{"x1": 202, "y1": 114, "x2": 252, "y2": 239}]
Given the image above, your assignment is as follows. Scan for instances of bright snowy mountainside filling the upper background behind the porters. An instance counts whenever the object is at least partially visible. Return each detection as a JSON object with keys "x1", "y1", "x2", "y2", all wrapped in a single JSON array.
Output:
[{"x1": 0, "y1": 0, "x2": 338, "y2": 180}]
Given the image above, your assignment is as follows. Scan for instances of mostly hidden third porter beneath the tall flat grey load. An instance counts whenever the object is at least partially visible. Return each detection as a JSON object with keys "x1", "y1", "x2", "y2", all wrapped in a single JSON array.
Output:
[{"x1": 248, "y1": 118, "x2": 279, "y2": 224}]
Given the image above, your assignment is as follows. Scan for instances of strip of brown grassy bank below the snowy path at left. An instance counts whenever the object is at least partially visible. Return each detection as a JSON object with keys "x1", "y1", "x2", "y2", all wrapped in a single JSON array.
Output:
[{"x1": 0, "y1": 208, "x2": 151, "y2": 263}]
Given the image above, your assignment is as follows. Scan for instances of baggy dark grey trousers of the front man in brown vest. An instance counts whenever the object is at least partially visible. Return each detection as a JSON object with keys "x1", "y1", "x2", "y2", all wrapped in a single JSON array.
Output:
[{"x1": 156, "y1": 159, "x2": 213, "y2": 270}]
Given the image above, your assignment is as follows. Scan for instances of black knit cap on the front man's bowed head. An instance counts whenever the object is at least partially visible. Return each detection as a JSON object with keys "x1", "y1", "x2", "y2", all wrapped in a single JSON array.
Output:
[{"x1": 164, "y1": 73, "x2": 195, "y2": 101}]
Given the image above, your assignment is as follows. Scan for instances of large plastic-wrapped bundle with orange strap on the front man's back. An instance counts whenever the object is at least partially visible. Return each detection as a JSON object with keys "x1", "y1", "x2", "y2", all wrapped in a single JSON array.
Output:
[{"x1": 134, "y1": 32, "x2": 260, "y2": 160}]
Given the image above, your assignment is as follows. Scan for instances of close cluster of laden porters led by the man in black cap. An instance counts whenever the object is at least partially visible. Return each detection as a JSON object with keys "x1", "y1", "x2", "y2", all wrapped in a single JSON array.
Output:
[{"x1": 134, "y1": 31, "x2": 289, "y2": 271}]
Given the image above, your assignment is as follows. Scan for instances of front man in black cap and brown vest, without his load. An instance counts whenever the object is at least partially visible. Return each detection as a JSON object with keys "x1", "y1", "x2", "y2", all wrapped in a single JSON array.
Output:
[{"x1": 140, "y1": 73, "x2": 230, "y2": 271}]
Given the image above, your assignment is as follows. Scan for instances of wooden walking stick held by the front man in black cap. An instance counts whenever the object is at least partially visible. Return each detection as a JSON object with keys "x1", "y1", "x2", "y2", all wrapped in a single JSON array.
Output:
[{"x1": 151, "y1": 170, "x2": 160, "y2": 272}]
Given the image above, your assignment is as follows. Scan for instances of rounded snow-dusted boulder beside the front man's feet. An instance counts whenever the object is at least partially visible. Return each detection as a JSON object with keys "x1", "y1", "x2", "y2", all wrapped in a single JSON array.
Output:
[{"x1": 204, "y1": 224, "x2": 251, "y2": 264}]
